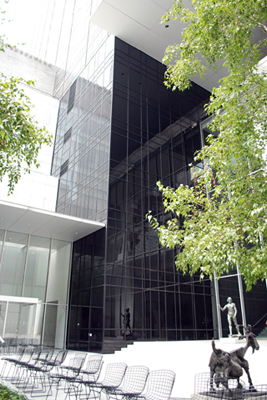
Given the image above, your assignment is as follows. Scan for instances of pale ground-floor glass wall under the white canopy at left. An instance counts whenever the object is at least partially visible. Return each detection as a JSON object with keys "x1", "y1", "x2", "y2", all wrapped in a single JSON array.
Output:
[{"x1": 0, "y1": 231, "x2": 71, "y2": 348}]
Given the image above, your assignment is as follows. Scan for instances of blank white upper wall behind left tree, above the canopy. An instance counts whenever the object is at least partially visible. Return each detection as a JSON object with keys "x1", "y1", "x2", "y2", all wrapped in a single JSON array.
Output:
[{"x1": 0, "y1": 48, "x2": 59, "y2": 211}]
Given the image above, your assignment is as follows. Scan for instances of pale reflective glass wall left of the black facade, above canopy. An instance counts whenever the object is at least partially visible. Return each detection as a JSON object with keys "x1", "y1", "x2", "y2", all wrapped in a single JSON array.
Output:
[{"x1": 52, "y1": 0, "x2": 114, "y2": 221}]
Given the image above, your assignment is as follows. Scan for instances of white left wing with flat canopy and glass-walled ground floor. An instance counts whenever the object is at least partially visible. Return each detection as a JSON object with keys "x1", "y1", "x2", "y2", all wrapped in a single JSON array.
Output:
[{"x1": 0, "y1": 48, "x2": 104, "y2": 348}]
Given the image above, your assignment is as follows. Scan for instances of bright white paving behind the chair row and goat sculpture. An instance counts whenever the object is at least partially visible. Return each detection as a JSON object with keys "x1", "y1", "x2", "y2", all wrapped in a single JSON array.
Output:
[{"x1": 0, "y1": 339, "x2": 267, "y2": 400}]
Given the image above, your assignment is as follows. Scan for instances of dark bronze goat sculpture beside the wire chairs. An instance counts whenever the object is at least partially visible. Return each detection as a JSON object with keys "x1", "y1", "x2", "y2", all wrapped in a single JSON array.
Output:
[{"x1": 209, "y1": 325, "x2": 260, "y2": 391}]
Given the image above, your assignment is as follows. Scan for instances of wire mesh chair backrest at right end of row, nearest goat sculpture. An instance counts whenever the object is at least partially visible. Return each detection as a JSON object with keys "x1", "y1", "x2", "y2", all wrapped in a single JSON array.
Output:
[{"x1": 143, "y1": 369, "x2": 176, "y2": 400}]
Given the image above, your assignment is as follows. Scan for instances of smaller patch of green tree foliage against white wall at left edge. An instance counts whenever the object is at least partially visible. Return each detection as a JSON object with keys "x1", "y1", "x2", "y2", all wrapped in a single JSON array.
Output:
[{"x1": 0, "y1": 1, "x2": 52, "y2": 194}]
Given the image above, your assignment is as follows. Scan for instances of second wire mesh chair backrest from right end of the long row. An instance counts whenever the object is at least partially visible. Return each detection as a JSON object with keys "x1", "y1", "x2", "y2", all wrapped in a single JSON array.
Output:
[{"x1": 118, "y1": 365, "x2": 149, "y2": 394}]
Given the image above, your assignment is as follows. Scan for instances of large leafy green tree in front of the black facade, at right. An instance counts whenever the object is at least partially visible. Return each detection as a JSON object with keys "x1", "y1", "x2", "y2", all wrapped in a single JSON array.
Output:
[{"x1": 148, "y1": 0, "x2": 267, "y2": 290}]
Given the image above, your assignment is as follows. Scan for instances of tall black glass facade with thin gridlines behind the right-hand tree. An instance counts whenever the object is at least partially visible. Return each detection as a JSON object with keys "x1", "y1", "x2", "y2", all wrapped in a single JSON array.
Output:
[{"x1": 67, "y1": 38, "x2": 220, "y2": 351}]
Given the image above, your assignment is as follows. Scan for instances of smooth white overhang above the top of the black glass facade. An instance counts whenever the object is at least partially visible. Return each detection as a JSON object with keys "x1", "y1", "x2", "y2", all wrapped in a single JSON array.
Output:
[{"x1": 91, "y1": 0, "x2": 267, "y2": 91}]
